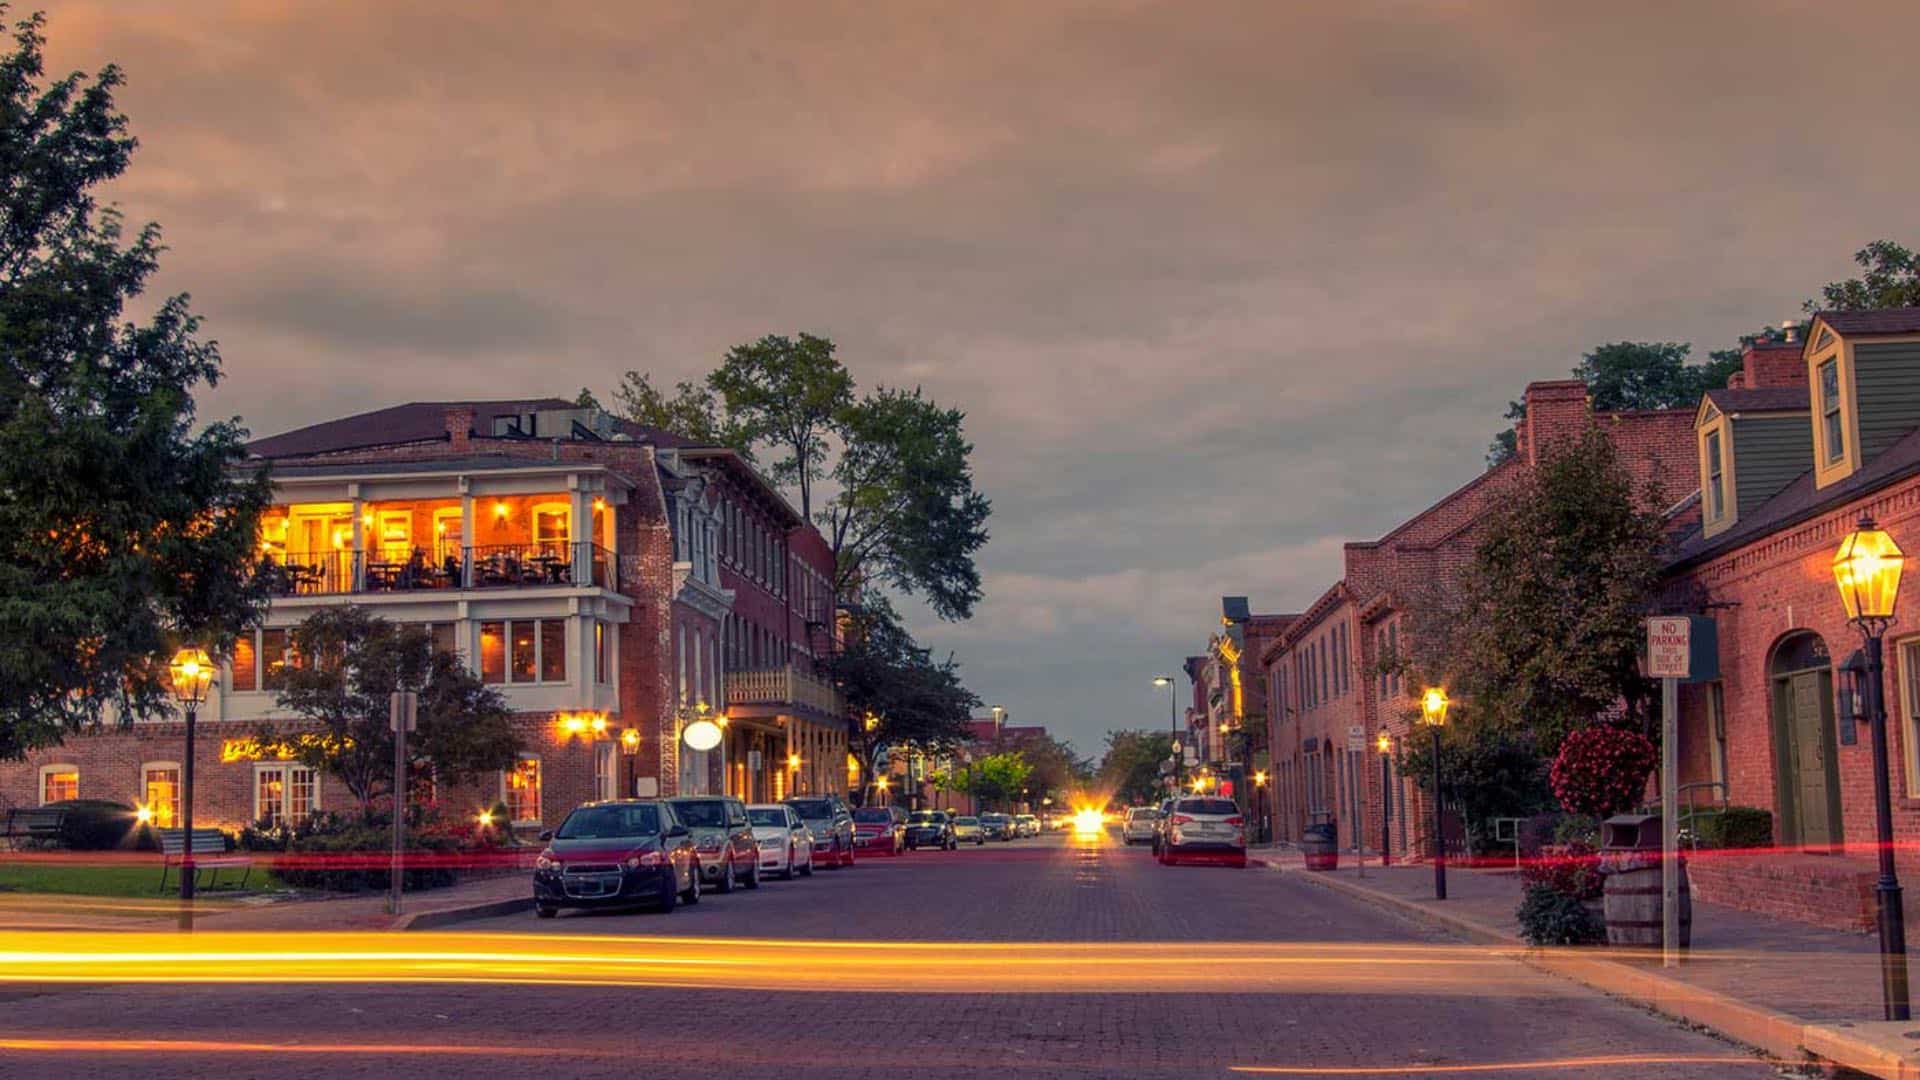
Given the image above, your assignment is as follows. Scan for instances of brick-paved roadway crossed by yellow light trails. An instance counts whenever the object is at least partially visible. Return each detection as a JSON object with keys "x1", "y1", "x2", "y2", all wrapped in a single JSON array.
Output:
[{"x1": 0, "y1": 836, "x2": 1797, "y2": 1080}]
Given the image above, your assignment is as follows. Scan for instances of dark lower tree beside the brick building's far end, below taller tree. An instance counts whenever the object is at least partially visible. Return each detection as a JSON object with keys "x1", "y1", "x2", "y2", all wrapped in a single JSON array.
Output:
[{"x1": 822, "y1": 596, "x2": 979, "y2": 792}]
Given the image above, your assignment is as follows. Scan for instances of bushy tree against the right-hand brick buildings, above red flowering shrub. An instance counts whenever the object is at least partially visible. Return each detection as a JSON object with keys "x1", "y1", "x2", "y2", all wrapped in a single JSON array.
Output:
[{"x1": 1411, "y1": 427, "x2": 1665, "y2": 755}]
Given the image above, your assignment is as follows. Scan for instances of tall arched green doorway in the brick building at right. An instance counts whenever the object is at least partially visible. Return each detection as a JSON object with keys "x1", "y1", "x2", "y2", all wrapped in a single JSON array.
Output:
[{"x1": 1766, "y1": 630, "x2": 1841, "y2": 849}]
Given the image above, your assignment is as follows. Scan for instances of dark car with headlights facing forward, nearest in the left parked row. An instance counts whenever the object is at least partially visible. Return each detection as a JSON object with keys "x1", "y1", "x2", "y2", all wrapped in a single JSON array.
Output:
[{"x1": 534, "y1": 799, "x2": 701, "y2": 919}]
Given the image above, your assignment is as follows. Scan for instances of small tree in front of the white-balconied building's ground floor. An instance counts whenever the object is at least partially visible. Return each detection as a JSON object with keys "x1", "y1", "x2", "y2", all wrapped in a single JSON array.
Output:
[{"x1": 257, "y1": 607, "x2": 520, "y2": 811}]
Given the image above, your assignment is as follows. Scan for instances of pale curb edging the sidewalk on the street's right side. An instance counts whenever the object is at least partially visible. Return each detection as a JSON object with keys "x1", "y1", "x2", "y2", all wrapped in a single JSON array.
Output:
[{"x1": 1261, "y1": 859, "x2": 1920, "y2": 1080}]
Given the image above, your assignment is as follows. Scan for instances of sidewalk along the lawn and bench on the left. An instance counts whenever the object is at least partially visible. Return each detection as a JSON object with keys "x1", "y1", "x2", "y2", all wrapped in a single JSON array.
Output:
[{"x1": 0, "y1": 874, "x2": 534, "y2": 934}]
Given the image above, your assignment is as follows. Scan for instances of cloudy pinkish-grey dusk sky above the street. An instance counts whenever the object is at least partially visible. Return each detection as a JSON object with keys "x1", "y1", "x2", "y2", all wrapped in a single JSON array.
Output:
[{"x1": 37, "y1": 0, "x2": 1920, "y2": 753}]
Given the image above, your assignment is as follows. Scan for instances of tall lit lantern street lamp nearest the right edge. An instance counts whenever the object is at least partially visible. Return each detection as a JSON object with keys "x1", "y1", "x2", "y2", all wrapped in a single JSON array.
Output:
[{"x1": 1834, "y1": 513, "x2": 1910, "y2": 1020}]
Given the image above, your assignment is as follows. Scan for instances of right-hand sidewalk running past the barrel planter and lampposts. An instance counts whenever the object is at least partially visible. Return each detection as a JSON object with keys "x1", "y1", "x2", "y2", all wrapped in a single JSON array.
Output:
[{"x1": 1250, "y1": 847, "x2": 1920, "y2": 1078}]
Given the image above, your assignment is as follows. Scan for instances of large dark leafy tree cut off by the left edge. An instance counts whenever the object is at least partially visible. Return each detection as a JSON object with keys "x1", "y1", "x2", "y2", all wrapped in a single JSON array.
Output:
[{"x1": 0, "y1": 6, "x2": 267, "y2": 757}]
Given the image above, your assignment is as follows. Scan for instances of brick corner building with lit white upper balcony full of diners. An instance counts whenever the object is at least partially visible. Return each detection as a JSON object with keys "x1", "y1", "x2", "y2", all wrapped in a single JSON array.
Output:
[{"x1": 0, "y1": 400, "x2": 845, "y2": 828}]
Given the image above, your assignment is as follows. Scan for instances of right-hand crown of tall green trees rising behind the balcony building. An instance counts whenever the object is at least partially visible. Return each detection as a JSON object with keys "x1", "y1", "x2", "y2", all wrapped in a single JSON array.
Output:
[{"x1": 820, "y1": 388, "x2": 993, "y2": 619}]
